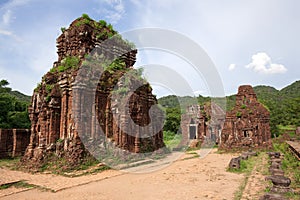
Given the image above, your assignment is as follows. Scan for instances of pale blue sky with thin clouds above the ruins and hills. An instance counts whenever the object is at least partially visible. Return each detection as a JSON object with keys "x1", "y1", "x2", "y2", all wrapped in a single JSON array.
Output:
[{"x1": 0, "y1": 0, "x2": 300, "y2": 96}]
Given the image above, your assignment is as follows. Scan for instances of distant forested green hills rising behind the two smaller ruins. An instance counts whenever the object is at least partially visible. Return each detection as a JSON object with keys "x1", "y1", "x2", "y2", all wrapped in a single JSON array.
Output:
[{"x1": 158, "y1": 81, "x2": 300, "y2": 133}]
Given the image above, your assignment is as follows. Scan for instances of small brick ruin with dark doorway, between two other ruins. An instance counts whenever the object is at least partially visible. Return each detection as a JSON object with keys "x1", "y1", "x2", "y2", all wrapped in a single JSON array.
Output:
[{"x1": 181, "y1": 102, "x2": 225, "y2": 143}]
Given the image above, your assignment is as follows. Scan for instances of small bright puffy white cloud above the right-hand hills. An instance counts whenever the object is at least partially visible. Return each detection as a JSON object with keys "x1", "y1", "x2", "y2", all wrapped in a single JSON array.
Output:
[{"x1": 245, "y1": 52, "x2": 287, "y2": 74}]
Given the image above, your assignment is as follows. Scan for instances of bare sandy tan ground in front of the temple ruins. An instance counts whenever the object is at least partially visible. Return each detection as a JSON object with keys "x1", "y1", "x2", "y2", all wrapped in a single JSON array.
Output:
[{"x1": 0, "y1": 150, "x2": 244, "y2": 200}]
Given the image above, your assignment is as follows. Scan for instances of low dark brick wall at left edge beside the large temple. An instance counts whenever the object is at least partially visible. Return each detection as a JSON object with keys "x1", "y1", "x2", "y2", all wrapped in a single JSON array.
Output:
[{"x1": 0, "y1": 129, "x2": 30, "y2": 159}]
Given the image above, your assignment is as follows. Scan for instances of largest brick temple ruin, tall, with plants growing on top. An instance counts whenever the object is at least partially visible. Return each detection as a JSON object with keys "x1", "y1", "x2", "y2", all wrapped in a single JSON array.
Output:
[{"x1": 23, "y1": 16, "x2": 164, "y2": 167}]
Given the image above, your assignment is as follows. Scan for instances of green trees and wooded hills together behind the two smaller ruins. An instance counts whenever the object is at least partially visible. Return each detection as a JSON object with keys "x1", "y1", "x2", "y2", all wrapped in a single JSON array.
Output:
[{"x1": 158, "y1": 81, "x2": 300, "y2": 135}]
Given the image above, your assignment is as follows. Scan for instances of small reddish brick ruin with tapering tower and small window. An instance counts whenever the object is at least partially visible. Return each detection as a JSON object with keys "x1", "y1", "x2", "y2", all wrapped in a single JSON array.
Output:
[{"x1": 220, "y1": 85, "x2": 271, "y2": 149}]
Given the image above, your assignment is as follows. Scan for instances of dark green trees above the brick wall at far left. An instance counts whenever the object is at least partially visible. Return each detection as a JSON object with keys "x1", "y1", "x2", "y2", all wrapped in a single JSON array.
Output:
[{"x1": 0, "y1": 80, "x2": 30, "y2": 128}]
